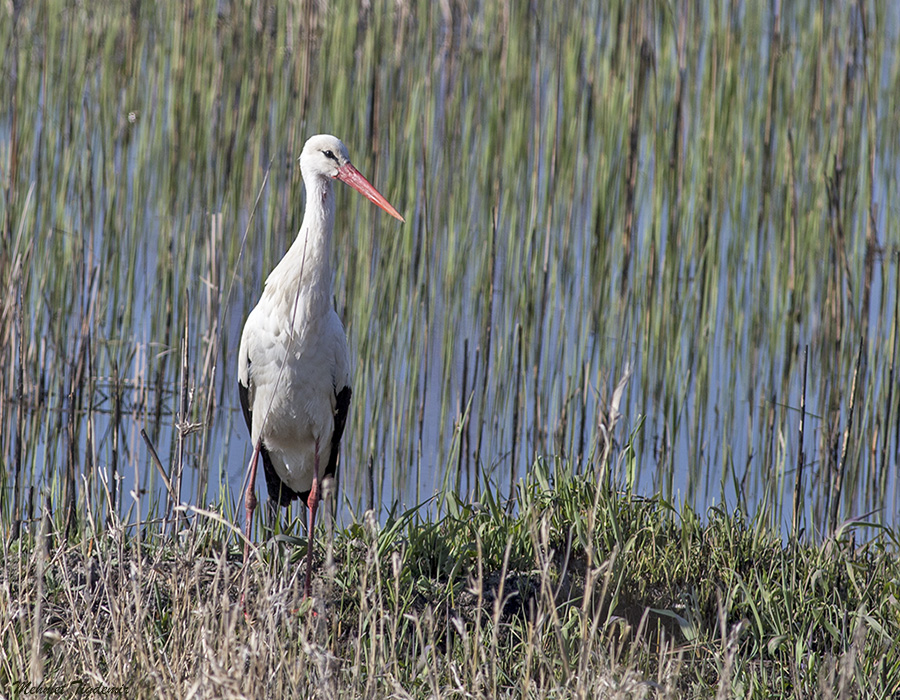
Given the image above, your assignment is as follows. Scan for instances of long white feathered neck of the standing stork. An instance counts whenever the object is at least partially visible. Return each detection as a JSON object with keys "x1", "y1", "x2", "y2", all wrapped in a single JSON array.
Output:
[{"x1": 264, "y1": 176, "x2": 334, "y2": 322}]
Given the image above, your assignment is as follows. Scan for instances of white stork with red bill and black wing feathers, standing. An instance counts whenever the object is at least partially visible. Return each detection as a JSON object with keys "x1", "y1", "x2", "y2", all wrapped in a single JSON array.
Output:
[{"x1": 238, "y1": 134, "x2": 404, "y2": 597}]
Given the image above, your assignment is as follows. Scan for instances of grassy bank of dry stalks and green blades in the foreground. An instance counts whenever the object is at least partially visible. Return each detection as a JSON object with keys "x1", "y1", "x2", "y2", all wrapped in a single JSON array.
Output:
[{"x1": 0, "y1": 463, "x2": 900, "y2": 698}]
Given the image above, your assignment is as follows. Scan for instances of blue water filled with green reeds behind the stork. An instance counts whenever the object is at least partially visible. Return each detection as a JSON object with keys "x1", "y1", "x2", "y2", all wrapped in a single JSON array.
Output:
[{"x1": 0, "y1": 4, "x2": 900, "y2": 532}]
